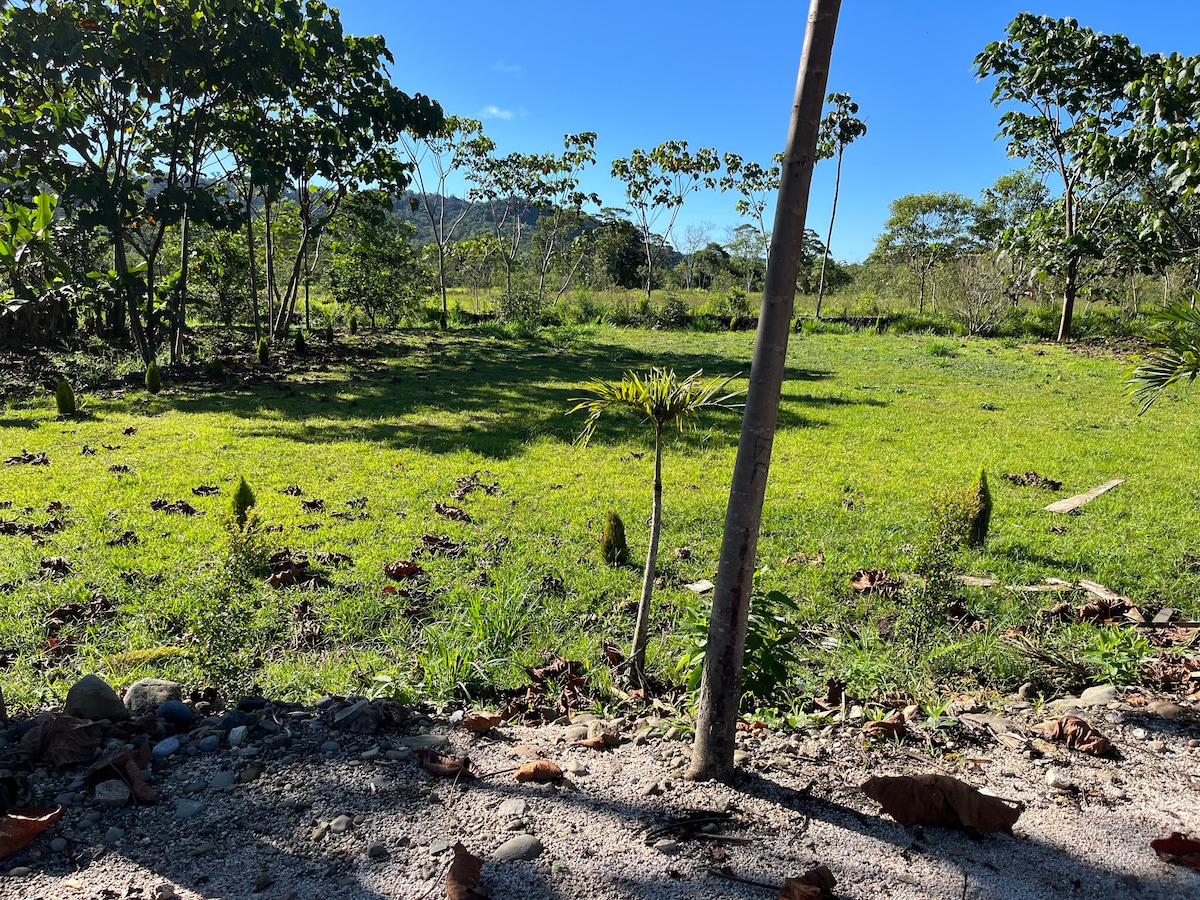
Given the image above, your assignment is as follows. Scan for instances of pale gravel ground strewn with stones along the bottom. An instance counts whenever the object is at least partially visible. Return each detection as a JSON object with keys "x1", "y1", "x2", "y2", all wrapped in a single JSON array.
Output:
[{"x1": 0, "y1": 690, "x2": 1200, "y2": 900}]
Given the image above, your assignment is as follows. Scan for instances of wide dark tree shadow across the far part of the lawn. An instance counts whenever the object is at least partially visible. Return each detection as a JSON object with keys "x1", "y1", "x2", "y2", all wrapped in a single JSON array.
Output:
[{"x1": 159, "y1": 336, "x2": 881, "y2": 458}]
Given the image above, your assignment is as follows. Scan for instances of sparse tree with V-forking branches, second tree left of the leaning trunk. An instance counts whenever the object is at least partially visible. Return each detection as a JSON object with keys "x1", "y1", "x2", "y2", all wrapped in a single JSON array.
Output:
[{"x1": 612, "y1": 140, "x2": 721, "y2": 299}]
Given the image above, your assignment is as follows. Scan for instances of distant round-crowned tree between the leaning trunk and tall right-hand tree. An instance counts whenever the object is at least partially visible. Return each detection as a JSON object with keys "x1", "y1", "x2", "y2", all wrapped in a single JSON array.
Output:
[{"x1": 875, "y1": 192, "x2": 974, "y2": 312}]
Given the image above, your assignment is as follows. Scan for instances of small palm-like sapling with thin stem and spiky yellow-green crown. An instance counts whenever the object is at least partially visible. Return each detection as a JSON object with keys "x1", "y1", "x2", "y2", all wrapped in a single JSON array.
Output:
[{"x1": 569, "y1": 367, "x2": 740, "y2": 683}]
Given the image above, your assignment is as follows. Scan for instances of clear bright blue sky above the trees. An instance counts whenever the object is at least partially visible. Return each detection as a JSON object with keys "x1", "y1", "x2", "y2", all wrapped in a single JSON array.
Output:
[{"x1": 335, "y1": 0, "x2": 1200, "y2": 259}]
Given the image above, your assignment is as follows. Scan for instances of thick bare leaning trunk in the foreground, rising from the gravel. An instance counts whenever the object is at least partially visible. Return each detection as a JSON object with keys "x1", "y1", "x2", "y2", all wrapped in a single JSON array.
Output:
[{"x1": 688, "y1": 0, "x2": 841, "y2": 780}]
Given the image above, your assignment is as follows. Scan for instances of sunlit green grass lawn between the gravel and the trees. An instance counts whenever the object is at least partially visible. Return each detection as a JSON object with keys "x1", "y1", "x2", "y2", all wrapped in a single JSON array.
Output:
[{"x1": 0, "y1": 326, "x2": 1200, "y2": 720}]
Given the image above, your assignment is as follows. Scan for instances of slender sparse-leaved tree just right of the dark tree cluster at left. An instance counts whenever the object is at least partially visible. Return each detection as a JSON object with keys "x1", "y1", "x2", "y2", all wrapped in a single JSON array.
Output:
[{"x1": 400, "y1": 115, "x2": 496, "y2": 328}]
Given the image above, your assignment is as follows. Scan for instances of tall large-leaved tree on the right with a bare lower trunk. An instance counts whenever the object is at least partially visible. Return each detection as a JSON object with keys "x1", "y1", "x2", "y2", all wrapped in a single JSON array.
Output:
[{"x1": 974, "y1": 12, "x2": 1142, "y2": 341}]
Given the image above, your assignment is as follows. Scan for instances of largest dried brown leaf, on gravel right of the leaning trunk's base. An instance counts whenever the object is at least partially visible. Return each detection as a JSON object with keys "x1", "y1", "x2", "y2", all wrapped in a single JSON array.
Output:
[{"x1": 863, "y1": 775, "x2": 1021, "y2": 834}]
